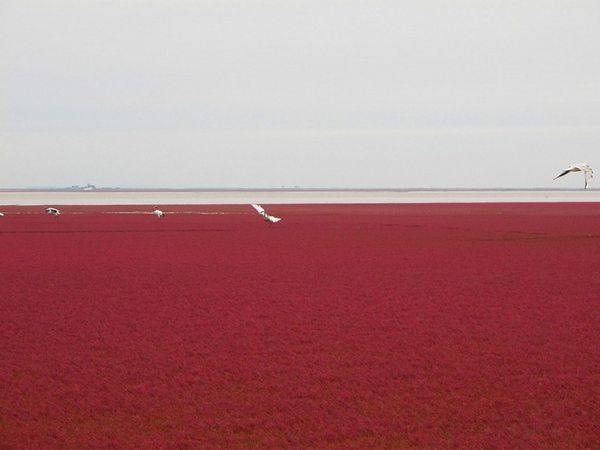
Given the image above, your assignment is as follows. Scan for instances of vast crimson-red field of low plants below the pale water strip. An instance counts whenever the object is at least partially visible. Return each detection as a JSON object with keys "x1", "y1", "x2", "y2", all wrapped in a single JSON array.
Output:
[{"x1": 0, "y1": 203, "x2": 600, "y2": 448}]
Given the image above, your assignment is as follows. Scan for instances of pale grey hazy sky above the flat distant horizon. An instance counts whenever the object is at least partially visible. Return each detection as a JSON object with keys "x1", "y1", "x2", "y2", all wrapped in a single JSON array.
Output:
[{"x1": 0, "y1": 0, "x2": 600, "y2": 188}]
